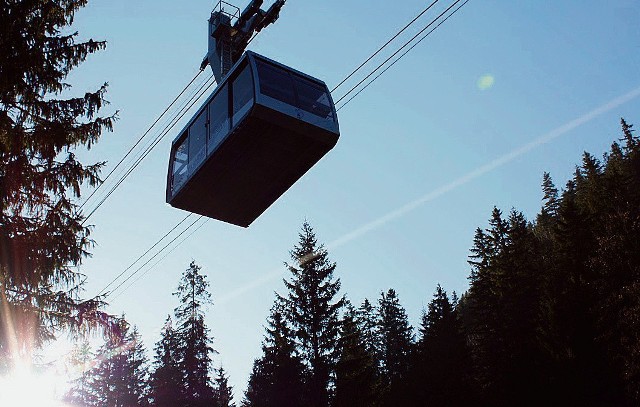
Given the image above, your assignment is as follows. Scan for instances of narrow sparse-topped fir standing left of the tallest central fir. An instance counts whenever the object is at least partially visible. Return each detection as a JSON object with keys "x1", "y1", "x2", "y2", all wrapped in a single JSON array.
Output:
[{"x1": 174, "y1": 261, "x2": 215, "y2": 407}]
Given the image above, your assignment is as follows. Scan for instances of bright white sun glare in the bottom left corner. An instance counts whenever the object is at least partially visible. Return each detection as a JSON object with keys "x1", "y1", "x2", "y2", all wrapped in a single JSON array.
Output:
[{"x1": 0, "y1": 369, "x2": 67, "y2": 407}]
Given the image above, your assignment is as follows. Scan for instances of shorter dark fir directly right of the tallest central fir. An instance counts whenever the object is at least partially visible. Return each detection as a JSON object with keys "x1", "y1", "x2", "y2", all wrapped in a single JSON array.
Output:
[{"x1": 333, "y1": 305, "x2": 380, "y2": 407}]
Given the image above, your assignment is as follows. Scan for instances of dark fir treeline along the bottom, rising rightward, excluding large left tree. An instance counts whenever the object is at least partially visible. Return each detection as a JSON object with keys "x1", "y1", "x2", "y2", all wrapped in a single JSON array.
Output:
[{"x1": 66, "y1": 120, "x2": 640, "y2": 407}]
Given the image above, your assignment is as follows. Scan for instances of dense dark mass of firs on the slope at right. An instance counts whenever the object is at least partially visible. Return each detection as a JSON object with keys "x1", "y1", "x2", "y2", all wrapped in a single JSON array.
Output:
[{"x1": 461, "y1": 120, "x2": 640, "y2": 406}]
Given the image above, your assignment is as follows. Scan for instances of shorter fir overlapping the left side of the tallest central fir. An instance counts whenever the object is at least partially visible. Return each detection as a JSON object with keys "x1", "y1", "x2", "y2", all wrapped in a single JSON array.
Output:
[{"x1": 242, "y1": 300, "x2": 307, "y2": 407}]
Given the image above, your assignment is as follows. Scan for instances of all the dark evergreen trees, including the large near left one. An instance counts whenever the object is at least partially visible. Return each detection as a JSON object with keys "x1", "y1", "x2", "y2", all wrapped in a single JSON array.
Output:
[{"x1": 0, "y1": 0, "x2": 640, "y2": 407}]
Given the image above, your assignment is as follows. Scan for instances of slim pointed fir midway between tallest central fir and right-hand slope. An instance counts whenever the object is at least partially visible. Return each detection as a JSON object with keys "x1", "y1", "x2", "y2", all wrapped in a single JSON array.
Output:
[{"x1": 378, "y1": 288, "x2": 413, "y2": 406}]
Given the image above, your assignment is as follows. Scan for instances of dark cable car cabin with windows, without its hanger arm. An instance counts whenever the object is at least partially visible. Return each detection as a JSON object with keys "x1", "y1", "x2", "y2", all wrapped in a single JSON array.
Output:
[{"x1": 167, "y1": 51, "x2": 340, "y2": 227}]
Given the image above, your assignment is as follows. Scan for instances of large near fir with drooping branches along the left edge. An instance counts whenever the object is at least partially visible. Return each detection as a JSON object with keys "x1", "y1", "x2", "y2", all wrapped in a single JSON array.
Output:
[{"x1": 0, "y1": 0, "x2": 114, "y2": 372}]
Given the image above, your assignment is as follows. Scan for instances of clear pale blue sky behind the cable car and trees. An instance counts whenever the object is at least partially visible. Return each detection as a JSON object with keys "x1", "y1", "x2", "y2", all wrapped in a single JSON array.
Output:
[{"x1": 57, "y1": 0, "x2": 640, "y2": 400}]
